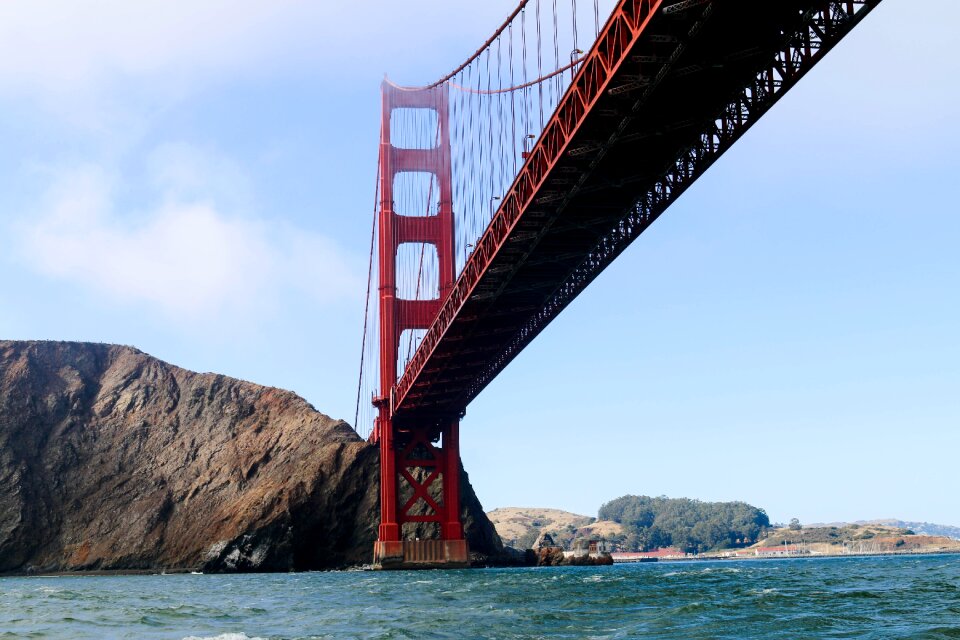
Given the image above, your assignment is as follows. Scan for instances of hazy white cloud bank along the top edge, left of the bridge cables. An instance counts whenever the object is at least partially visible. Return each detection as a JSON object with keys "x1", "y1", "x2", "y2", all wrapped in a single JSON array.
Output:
[{"x1": 0, "y1": 0, "x2": 528, "y2": 140}]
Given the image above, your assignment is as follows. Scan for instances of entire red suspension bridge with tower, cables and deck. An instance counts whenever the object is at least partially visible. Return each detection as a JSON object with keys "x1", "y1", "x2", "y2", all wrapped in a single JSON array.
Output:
[{"x1": 356, "y1": 0, "x2": 880, "y2": 567}]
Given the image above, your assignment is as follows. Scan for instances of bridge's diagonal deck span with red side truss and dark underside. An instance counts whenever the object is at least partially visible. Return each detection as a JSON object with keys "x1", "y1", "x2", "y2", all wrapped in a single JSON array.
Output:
[{"x1": 384, "y1": 0, "x2": 880, "y2": 425}]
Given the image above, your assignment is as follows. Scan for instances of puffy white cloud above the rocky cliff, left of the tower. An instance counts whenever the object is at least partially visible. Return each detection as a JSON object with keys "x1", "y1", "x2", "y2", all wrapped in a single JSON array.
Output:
[{"x1": 16, "y1": 144, "x2": 361, "y2": 322}]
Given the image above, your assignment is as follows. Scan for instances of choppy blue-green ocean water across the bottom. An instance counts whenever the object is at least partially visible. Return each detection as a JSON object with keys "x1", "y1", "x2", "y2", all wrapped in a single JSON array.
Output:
[{"x1": 0, "y1": 555, "x2": 960, "y2": 640}]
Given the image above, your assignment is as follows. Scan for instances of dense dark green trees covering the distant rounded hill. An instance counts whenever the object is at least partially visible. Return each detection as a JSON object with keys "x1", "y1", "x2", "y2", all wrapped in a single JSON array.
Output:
[{"x1": 598, "y1": 495, "x2": 770, "y2": 553}]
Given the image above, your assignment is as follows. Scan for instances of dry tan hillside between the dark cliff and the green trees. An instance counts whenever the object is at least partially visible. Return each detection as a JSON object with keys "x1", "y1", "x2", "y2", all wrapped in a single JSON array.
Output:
[{"x1": 487, "y1": 507, "x2": 624, "y2": 549}]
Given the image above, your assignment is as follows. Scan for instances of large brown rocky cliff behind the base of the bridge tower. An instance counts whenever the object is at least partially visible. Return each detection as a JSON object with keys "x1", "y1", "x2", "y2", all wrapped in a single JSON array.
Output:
[{"x1": 0, "y1": 341, "x2": 502, "y2": 572}]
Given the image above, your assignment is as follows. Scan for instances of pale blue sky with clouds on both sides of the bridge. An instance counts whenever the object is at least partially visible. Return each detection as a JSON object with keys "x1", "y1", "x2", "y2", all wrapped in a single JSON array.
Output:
[{"x1": 0, "y1": 0, "x2": 960, "y2": 525}]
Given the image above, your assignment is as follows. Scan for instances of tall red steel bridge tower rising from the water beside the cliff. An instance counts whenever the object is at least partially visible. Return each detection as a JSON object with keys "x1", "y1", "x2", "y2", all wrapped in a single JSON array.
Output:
[{"x1": 372, "y1": 81, "x2": 469, "y2": 568}]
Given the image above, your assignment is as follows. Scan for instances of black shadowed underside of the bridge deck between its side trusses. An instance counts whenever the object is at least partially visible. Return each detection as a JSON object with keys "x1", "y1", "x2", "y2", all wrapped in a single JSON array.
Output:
[{"x1": 395, "y1": 0, "x2": 872, "y2": 425}]
